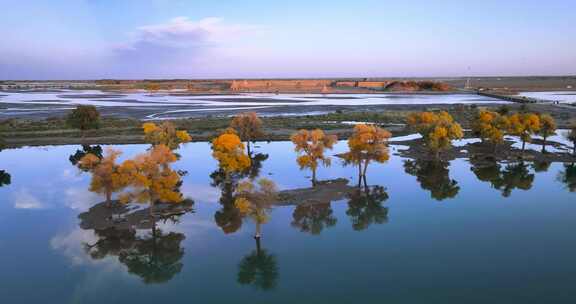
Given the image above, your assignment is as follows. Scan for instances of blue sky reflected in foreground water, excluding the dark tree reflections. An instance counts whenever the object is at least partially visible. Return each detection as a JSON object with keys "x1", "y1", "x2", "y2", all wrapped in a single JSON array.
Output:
[{"x1": 0, "y1": 142, "x2": 576, "y2": 303}]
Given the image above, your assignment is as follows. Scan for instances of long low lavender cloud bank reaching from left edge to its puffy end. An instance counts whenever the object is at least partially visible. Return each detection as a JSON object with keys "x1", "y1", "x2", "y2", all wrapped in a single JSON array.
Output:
[{"x1": 0, "y1": 17, "x2": 261, "y2": 79}]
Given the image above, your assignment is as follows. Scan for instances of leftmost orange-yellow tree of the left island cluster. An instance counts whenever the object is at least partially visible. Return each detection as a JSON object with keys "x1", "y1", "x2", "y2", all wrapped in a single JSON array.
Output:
[{"x1": 78, "y1": 149, "x2": 129, "y2": 207}]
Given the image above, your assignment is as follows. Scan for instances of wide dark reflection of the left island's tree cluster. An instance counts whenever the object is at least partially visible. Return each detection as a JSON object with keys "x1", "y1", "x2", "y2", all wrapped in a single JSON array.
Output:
[{"x1": 79, "y1": 201, "x2": 192, "y2": 284}]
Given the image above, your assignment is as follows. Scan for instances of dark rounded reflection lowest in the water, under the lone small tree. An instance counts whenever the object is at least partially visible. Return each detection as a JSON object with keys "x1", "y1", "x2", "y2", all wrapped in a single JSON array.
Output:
[{"x1": 237, "y1": 238, "x2": 278, "y2": 290}]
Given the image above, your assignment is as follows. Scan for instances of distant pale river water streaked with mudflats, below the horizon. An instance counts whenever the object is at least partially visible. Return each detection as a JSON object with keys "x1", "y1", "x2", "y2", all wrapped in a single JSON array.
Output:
[{"x1": 0, "y1": 90, "x2": 506, "y2": 119}]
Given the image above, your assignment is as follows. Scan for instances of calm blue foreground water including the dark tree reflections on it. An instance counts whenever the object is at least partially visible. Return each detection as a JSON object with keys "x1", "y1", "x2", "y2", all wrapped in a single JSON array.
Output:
[{"x1": 0, "y1": 142, "x2": 576, "y2": 303}]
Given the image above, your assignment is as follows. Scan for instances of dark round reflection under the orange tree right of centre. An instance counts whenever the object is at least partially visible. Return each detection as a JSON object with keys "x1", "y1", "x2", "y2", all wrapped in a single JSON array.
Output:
[{"x1": 346, "y1": 186, "x2": 388, "y2": 230}]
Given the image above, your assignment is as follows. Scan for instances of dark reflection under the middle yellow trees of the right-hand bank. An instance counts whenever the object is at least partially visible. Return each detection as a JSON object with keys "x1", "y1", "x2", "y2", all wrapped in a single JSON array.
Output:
[{"x1": 471, "y1": 161, "x2": 536, "y2": 197}]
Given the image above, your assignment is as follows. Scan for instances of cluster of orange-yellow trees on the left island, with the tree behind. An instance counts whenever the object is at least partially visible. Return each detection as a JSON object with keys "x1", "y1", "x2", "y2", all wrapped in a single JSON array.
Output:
[{"x1": 77, "y1": 122, "x2": 190, "y2": 215}]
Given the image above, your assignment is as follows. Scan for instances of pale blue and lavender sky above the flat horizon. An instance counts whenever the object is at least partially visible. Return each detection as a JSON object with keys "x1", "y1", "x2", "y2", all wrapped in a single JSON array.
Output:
[{"x1": 0, "y1": 0, "x2": 576, "y2": 80}]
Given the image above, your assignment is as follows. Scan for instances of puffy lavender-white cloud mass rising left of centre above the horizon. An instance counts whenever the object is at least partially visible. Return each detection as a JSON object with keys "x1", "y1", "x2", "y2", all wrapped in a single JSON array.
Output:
[{"x1": 111, "y1": 17, "x2": 259, "y2": 78}]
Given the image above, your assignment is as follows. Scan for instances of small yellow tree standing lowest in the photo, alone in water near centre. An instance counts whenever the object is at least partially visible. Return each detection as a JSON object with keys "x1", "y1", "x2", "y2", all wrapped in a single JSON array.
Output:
[{"x1": 234, "y1": 178, "x2": 278, "y2": 239}]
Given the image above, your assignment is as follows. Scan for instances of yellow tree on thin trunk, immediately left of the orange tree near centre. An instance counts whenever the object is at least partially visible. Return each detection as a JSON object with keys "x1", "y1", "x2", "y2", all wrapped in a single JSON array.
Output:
[{"x1": 290, "y1": 129, "x2": 338, "y2": 186}]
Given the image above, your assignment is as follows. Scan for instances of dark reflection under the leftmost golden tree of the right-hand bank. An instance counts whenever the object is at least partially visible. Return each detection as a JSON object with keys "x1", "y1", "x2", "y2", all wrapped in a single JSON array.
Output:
[{"x1": 404, "y1": 159, "x2": 460, "y2": 201}]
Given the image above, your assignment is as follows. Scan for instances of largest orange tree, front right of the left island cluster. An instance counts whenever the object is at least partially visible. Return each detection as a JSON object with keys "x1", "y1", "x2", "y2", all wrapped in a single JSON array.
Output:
[{"x1": 119, "y1": 145, "x2": 183, "y2": 215}]
